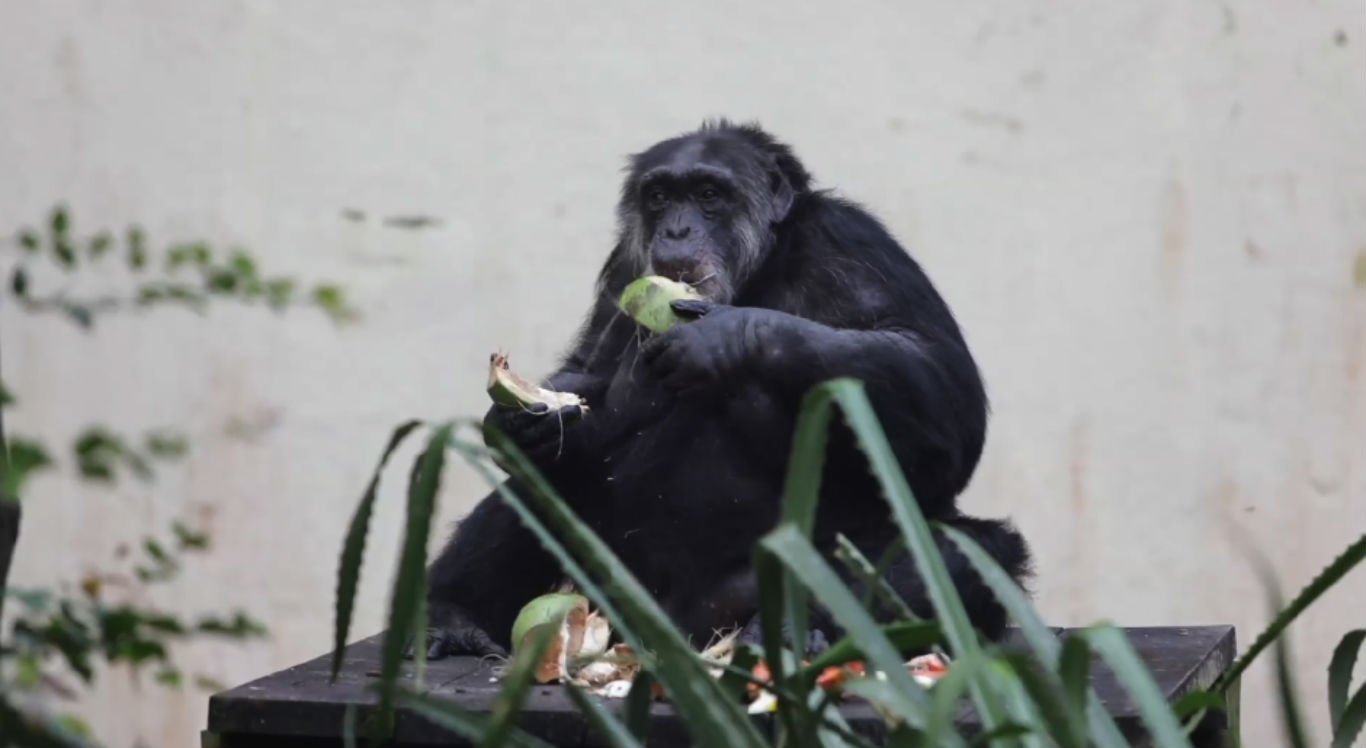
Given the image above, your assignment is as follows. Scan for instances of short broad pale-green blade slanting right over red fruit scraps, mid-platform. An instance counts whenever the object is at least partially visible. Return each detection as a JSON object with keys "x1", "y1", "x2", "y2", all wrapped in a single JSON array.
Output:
[{"x1": 759, "y1": 524, "x2": 929, "y2": 728}]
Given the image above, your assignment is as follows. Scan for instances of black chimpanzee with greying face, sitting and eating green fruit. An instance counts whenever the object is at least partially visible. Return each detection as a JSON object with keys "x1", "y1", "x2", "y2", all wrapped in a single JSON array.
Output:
[{"x1": 428, "y1": 120, "x2": 1029, "y2": 658}]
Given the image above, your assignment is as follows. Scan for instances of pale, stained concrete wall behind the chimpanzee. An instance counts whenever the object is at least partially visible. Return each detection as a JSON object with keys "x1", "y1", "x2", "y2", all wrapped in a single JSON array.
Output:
[{"x1": 0, "y1": 0, "x2": 1366, "y2": 745}]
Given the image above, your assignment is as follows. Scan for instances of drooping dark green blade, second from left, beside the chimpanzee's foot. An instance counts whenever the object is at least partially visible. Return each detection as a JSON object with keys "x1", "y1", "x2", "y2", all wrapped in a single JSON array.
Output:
[{"x1": 378, "y1": 423, "x2": 452, "y2": 726}]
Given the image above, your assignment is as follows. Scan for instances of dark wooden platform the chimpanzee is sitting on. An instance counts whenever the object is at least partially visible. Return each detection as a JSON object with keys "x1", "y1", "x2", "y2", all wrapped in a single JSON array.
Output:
[{"x1": 204, "y1": 627, "x2": 1236, "y2": 748}]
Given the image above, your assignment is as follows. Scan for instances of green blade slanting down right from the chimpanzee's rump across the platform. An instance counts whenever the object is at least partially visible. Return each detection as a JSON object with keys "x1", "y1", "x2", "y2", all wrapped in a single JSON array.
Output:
[{"x1": 943, "y1": 527, "x2": 1128, "y2": 748}]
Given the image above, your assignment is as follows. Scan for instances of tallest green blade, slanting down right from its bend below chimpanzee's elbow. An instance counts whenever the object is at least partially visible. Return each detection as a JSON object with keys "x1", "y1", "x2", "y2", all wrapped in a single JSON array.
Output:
[{"x1": 821, "y1": 379, "x2": 1005, "y2": 730}]
